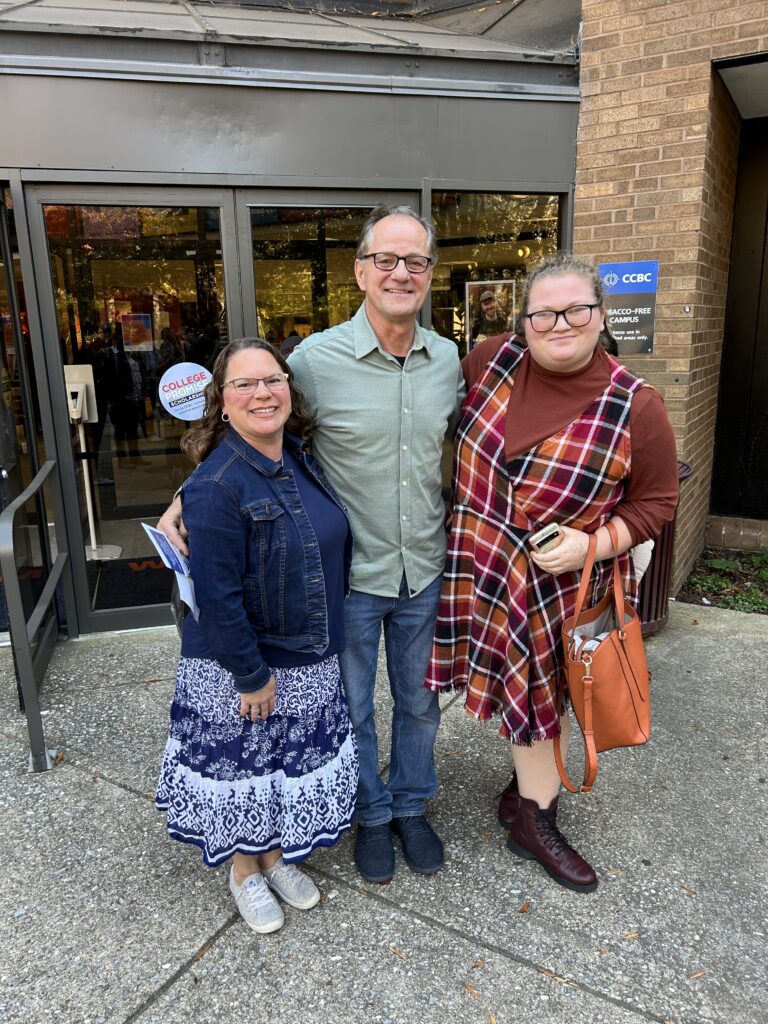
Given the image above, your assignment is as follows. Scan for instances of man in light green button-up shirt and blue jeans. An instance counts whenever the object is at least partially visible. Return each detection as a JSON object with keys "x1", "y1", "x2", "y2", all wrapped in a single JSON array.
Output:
[{"x1": 289, "y1": 207, "x2": 464, "y2": 883}]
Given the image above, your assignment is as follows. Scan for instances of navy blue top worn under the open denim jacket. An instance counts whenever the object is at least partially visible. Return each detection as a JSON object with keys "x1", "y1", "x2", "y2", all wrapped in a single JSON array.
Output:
[{"x1": 181, "y1": 445, "x2": 348, "y2": 671}]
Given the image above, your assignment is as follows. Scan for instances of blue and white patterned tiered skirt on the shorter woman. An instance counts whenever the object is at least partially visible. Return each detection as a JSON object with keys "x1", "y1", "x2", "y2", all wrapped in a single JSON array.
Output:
[{"x1": 156, "y1": 655, "x2": 357, "y2": 867}]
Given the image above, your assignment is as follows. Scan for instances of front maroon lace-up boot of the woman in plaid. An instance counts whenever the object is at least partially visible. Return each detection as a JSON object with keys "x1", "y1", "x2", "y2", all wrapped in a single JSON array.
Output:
[{"x1": 507, "y1": 797, "x2": 597, "y2": 893}]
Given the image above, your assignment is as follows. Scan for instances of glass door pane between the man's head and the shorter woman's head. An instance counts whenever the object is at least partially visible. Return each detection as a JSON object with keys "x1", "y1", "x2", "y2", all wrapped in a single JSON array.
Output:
[{"x1": 251, "y1": 207, "x2": 371, "y2": 350}]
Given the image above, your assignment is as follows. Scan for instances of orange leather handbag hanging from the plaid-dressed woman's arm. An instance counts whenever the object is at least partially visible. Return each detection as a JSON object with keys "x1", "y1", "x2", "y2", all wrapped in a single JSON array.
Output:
[{"x1": 553, "y1": 523, "x2": 650, "y2": 793}]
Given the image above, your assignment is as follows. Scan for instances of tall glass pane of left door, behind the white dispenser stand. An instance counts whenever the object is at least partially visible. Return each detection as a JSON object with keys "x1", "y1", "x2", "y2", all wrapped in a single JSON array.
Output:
[{"x1": 44, "y1": 205, "x2": 228, "y2": 609}]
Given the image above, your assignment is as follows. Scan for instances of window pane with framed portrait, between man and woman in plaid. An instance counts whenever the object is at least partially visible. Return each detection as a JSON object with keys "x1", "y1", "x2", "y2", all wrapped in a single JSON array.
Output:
[{"x1": 432, "y1": 193, "x2": 560, "y2": 354}]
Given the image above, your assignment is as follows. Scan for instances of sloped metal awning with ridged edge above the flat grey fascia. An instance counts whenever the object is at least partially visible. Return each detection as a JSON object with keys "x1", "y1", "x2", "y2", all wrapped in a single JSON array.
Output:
[{"x1": 0, "y1": 0, "x2": 578, "y2": 102}]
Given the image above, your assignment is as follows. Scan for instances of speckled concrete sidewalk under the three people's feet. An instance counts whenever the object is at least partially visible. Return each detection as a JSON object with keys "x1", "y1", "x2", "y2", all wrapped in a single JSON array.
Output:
[{"x1": 0, "y1": 604, "x2": 768, "y2": 1024}]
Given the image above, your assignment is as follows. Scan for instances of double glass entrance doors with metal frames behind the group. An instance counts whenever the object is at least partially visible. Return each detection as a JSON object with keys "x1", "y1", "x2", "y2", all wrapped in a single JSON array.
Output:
[{"x1": 27, "y1": 185, "x2": 419, "y2": 632}]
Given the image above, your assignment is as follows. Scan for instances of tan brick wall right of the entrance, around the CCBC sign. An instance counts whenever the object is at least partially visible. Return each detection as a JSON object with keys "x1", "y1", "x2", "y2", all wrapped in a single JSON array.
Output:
[{"x1": 573, "y1": 0, "x2": 768, "y2": 592}]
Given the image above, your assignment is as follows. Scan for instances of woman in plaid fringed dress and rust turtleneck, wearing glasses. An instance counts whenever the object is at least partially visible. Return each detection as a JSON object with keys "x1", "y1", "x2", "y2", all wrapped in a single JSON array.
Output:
[{"x1": 427, "y1": 253, "x2": 678, "y2": 892}]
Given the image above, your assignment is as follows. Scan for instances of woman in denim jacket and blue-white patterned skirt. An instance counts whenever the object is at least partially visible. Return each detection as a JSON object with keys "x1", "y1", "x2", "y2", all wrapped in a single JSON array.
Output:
[{"x1": 157, "y1": 339, "x2": 357, "y2": 933}]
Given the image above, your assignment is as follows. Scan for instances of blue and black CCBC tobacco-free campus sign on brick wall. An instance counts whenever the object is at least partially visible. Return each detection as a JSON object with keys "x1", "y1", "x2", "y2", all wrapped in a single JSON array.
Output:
[{"x1": 597, "y1": 259, "x2": 658, "y2": 355}]
